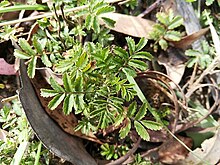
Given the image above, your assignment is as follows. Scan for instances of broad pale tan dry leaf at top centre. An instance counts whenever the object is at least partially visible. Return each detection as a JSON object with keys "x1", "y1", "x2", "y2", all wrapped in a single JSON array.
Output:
[{"x1": 101, "y1": 13, "x2": 155, "y2": 38}]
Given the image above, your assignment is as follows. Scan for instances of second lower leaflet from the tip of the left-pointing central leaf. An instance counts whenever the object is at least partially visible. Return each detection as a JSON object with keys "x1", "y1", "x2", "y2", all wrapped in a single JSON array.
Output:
[{"x1": 63, "y1": 94, "x2": 74, "y2": 115}]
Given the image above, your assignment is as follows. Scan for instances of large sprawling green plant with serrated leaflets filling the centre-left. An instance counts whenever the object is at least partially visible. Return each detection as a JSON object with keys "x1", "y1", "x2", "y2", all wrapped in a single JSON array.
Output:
[{"x1": 11, "y1": 1, "x2": 166, "y2": 159}]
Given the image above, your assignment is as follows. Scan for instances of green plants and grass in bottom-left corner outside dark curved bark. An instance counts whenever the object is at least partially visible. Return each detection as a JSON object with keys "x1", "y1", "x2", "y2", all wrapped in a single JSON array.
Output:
[{"x1": 0, "y1": 100, "x2": 50, "y2": 165}]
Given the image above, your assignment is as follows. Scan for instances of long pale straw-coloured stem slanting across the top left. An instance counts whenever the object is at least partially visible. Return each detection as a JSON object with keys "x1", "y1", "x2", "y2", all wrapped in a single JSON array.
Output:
[{"x1": 0, "y1": 0, "x2": 122, "y2": 27}]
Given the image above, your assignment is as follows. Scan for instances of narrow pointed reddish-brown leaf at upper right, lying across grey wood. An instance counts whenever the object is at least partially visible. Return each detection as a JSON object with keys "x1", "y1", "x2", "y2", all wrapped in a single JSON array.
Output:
[{"x1": 170, "y1": 28, "x2": 209, "y2": 49}]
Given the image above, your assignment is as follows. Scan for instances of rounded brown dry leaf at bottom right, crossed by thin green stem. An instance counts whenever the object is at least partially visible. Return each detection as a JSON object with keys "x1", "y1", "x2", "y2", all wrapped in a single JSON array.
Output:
[{"x1": 158, "y1": 136, "x2": 192, "y2": 164}]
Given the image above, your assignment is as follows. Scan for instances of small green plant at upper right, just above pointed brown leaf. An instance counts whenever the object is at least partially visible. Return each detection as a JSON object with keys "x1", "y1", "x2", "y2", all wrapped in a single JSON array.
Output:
[{"x1": 149, "y1": 10, "x2": 183, "y2": 52}]
